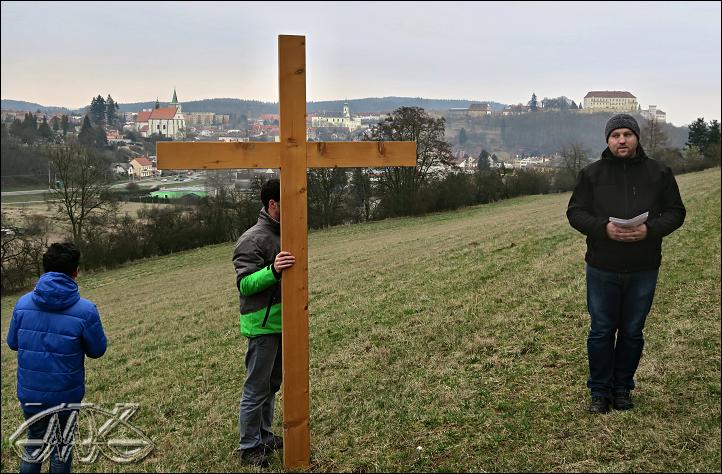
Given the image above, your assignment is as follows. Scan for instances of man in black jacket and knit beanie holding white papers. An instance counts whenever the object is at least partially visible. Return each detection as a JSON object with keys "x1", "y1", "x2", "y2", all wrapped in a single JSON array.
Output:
[{"x1": 567, "y1": 114, "x2": 686, "y2": 413}]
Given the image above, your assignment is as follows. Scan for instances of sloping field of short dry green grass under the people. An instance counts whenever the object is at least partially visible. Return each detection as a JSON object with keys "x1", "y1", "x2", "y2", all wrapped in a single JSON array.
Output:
[{"x1": 1, "y1": 169, "x2": 720, "y2": 472}]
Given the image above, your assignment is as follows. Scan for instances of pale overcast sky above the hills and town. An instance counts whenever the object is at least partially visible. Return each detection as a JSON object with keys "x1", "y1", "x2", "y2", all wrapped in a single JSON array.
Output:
[{"x1": 1, "y1": 1, "x2": 721, "y2": 125}]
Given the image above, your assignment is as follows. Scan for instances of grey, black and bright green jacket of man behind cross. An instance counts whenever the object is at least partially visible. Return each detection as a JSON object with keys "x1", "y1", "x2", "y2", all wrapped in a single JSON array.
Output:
[{"x1": 233, "y1": 209, "x2": 281, "y2": 337}]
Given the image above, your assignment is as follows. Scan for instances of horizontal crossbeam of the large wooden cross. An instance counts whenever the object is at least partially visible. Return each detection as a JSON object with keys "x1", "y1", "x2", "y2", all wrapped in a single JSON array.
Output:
[{"x1": 157, "y1": 142, "x2": 416, "y2": 170}]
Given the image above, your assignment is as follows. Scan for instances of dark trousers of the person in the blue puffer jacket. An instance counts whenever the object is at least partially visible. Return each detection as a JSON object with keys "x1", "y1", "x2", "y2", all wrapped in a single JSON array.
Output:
[{"x1": 19, "y1": 410, "x2": 75, "y2": 473}]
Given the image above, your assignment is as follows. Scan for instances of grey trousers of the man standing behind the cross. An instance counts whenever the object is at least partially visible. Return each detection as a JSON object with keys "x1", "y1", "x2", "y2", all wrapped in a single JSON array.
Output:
[{"x1": 238, "y1": 334, "x2": 283, "y2": 450}]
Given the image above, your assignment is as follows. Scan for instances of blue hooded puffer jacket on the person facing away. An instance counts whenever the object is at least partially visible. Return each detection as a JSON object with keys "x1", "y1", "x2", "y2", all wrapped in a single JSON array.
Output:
[{"x1": 7, "y1": 272, "x2": 108, "y2": 413}]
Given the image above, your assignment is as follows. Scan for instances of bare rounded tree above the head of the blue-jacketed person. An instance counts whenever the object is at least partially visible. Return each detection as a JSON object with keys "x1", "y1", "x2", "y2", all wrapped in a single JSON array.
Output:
[{"x1": 46, "y1": 144, "x2": 116, "y2": 247}]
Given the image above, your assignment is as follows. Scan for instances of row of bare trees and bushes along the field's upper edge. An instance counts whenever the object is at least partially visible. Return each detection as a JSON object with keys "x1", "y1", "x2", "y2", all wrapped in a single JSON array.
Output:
[{"x1": 2, "y1": 107, "x2": 720, "y2": 291}]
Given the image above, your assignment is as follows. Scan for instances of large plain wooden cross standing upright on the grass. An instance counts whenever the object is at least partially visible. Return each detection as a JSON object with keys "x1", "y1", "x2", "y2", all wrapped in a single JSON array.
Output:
[{"x1": 157, "y1": 35, "x2": 416, "y2": 468}]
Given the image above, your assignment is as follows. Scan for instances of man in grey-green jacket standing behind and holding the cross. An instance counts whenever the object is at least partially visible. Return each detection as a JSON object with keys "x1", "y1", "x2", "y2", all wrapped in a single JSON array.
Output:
[{"x1": 233, "y1": 179, "x2": 296, "y2": 467}]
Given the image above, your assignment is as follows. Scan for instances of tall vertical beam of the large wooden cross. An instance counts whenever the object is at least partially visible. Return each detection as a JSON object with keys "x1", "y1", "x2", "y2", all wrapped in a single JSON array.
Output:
[{"x1": 278, "y1": 35, "x2": 310, "y2": 468}]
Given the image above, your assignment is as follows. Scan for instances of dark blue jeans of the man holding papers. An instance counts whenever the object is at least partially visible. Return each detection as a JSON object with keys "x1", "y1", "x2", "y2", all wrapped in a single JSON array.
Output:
[{"x1": 586, "y1": 265, "x2": 659, "y2": 396}]
